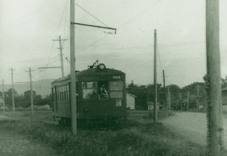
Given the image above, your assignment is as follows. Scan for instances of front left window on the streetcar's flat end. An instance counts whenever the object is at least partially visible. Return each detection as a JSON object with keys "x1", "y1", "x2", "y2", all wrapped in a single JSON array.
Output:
[{"x1": 82, "y1": 82, "x2": 98, "y2": 99}]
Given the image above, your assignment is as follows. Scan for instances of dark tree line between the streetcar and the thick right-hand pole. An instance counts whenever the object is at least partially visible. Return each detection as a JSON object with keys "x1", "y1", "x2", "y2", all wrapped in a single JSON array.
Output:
[{"x1": 127, "y1": 81, "x2": 206, "y2": 111}]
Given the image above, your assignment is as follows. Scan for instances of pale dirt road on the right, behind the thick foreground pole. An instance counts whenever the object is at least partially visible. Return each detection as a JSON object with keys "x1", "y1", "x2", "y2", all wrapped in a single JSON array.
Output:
[{"x1": 162, "y1": 112, "x2": 227, "y2": 149}]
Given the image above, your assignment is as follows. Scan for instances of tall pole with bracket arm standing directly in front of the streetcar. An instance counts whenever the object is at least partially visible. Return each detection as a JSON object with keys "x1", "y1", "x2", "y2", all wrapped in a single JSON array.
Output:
[{"x1": 70, "y1": 0, "x2": 77, "y2": 135}]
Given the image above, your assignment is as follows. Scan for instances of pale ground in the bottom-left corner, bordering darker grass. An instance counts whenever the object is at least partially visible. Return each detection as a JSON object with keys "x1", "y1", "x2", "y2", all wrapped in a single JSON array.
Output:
[{"x1": 0, "y1": 115, "x2": 57, "y2": 156}]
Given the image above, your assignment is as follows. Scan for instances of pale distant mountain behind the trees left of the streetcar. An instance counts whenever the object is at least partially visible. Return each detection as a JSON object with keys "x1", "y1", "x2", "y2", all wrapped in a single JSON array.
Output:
[{"x1": 4, "y1": 79, "x2": 54, "y2": 96}]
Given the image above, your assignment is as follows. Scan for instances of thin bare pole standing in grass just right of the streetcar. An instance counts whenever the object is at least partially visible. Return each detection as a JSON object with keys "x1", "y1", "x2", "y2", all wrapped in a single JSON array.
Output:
[{"x1": 154, "y1": 29, "x2": 158, "y2": 124}]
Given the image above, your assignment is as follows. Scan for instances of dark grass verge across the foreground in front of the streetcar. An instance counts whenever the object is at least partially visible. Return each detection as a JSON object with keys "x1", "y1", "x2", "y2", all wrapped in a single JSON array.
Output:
[{"x1": 0, "y1": 116, "x2": 207, "y2": 156}]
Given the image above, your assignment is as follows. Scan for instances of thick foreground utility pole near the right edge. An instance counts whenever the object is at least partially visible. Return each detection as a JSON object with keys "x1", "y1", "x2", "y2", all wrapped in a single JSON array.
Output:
[{"x1": 206, "y1": 0, "x2": 224, "y2": 156}]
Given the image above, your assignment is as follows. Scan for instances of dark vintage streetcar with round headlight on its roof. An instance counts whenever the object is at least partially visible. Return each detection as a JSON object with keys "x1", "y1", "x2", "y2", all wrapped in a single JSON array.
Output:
[{"x1": 51, "y1": 64, "x2": 126, "y2": 126}]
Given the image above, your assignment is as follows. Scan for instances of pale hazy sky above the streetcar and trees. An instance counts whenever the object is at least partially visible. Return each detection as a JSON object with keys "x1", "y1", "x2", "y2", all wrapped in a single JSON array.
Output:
[{"x1": 0, "y1": 0, "x2": 227, "y2": 87}]
